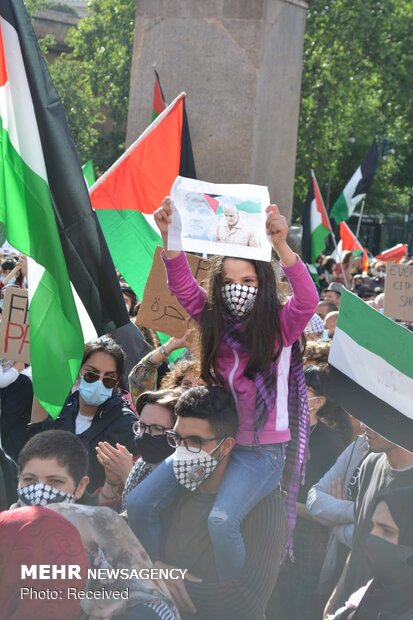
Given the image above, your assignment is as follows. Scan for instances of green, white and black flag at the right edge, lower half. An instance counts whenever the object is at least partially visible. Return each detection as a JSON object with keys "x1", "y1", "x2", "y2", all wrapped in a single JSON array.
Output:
[{"x1": 328, "y1": 287, "x2": 413, "y2": 452}]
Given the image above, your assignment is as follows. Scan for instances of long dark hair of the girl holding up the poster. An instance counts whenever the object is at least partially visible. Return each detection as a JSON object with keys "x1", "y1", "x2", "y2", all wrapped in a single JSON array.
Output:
[{"x1": 200, "y1": 256, "x2": 283, "y2": 385}]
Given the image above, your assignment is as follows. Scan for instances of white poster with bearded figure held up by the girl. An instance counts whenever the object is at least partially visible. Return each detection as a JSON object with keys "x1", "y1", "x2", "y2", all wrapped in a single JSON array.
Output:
[{"x1": 168, "y1": 177, "x2": 271, "y2": 261}]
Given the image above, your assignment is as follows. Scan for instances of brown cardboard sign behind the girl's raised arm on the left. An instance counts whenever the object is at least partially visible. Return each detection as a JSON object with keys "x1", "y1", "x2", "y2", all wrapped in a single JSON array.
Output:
[{"x1": 136, "y1": 247, "x2": 210, "y2": 338}]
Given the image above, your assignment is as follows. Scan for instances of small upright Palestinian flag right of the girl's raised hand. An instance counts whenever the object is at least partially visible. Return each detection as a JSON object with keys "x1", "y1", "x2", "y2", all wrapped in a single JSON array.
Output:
[{"x1": 301, "y1": 171, "x2": 332, "y2": 264}]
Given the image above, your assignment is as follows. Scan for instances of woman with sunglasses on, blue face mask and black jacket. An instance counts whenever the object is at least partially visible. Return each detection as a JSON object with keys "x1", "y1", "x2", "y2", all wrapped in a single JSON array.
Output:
[{"x1": 28, "y1": 338, "x2": 136, "y2": 494}]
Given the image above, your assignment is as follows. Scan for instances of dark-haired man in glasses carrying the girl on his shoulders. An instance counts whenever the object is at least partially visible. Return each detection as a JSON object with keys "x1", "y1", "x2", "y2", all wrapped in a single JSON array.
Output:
[{"x1": 126, "y1": 386, "x2": 287, "y2": 620}]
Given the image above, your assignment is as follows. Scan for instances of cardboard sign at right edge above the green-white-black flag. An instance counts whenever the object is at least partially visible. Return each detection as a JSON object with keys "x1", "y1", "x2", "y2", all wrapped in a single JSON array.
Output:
[{"x1": 384, "y1": 263, "x2": 413, "y2": 323}]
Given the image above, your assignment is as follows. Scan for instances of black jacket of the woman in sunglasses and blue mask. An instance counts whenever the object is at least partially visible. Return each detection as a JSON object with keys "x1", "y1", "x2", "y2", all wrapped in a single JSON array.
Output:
[{"x1": 28, "y1": 392, "x2": 137, "y2": 493}]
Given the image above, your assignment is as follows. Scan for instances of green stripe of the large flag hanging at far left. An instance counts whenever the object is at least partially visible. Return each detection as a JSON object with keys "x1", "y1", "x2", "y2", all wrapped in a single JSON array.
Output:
[{"x1": 0, "y1": 119, "x2": 84, "y2": 416}]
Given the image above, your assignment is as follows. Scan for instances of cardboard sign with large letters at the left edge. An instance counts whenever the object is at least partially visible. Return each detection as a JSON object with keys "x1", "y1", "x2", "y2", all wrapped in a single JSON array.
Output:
[{"x1": 0, "y1": 287, "x2": 30, "y2": 364}]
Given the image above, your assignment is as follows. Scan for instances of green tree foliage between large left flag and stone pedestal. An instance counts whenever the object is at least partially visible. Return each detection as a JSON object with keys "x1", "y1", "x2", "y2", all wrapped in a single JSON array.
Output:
[{"x1": 31, "y1": 0, "x2": 136, "y2": 172}]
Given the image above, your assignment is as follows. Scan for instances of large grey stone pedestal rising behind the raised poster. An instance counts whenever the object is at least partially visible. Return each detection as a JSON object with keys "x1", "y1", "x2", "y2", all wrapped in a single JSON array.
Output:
[{"x1": 127, "y1": 0, "x2": 308, "y2": 223}]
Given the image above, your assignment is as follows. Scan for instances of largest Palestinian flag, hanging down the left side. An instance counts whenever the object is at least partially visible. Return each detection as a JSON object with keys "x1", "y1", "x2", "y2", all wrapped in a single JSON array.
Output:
[{"x1": 0, "y1": 0, "x2": 128, "y2": 416}]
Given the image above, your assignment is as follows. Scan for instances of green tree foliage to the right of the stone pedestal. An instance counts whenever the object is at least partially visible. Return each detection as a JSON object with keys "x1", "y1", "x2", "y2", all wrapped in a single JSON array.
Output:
[{"x1": 294, "y1": 0, "x2": 413, "y2": 223}]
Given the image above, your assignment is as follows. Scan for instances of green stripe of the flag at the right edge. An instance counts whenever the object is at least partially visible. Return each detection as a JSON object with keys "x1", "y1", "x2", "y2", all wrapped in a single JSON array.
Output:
[{"x1": 337, "y1": 287, "x2": 413, "y2": 379}]
